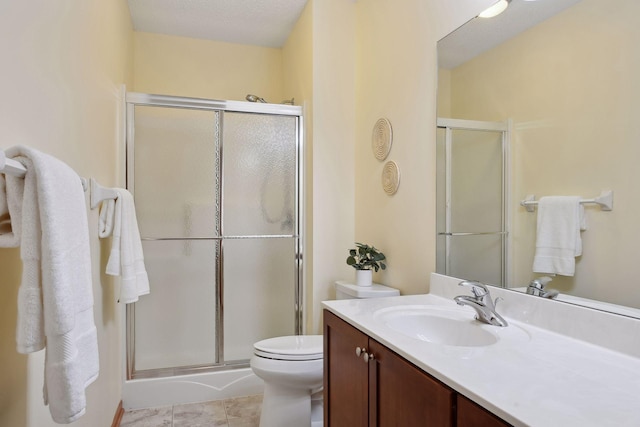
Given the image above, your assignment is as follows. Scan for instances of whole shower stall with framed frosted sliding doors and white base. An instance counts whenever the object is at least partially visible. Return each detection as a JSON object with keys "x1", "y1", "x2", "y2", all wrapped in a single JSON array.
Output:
[{"x1": 123, "y1": 93, "x2": 303, "y2": 408}]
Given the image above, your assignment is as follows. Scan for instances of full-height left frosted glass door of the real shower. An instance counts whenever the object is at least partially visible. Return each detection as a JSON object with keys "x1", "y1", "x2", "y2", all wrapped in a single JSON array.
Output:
[{"x1": 129, "y1": 106, "x2": 219, "y2": 371}]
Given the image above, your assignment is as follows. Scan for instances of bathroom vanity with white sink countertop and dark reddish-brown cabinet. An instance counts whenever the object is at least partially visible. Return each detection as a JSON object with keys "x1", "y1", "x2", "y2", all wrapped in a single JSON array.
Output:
[{"x1": 323, "y1": 274, "x2": 640, "y2": 427}]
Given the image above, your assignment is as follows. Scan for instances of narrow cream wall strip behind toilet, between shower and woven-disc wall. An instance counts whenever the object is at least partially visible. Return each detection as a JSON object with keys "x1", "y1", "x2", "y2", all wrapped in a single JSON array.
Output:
[{"x1": 308, "y1": 0, "x2": 356, "y2": 333}]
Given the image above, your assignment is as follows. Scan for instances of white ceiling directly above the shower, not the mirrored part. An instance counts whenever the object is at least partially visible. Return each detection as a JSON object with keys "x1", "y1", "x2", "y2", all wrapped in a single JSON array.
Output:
[{"x1": 128, "y1": 0, "x2": 307, "y2": 48}]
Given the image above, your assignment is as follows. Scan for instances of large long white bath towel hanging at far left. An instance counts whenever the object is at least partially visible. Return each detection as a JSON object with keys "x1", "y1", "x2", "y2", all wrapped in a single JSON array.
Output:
[{"x1": 6, "y1": 146, "x2": 99, "y2": 423}]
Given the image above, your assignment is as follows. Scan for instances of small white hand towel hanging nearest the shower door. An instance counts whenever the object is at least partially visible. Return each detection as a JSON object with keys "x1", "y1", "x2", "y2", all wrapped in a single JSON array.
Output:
[{"x1": 106, "y1": 188, "x2": 149, "y2": 304}]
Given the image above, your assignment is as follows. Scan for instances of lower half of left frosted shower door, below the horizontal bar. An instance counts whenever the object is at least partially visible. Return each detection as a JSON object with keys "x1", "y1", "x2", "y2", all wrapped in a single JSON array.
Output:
[{"x1": 134, "y1": 240, "x2": 218, "y2": 370}]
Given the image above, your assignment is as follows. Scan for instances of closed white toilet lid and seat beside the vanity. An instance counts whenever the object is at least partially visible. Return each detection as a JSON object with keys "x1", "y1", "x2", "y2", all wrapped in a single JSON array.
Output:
[{"x1": 253, "y1": 335, "x2": 323, "y2": 360}]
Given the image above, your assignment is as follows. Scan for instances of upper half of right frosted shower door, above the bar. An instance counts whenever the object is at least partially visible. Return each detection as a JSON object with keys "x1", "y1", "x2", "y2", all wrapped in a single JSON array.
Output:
[{"x1": 222, "y1": 112, "x2": 297, "y2": 236}]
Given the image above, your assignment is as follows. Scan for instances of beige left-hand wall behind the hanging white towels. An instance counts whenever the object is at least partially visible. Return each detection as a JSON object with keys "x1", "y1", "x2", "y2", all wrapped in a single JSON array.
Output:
[{"x1": 0, "y1": 0, "x2": 132, "y2": 427}]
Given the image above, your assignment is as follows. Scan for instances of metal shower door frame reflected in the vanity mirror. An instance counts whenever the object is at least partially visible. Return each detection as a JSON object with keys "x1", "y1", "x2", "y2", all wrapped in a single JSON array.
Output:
[{"x1": 437, "y1": 117, "x2": 512, "y2": 288}]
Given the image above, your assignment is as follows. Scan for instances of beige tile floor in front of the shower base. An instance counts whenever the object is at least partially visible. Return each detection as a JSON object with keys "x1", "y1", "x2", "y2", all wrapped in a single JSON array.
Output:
[{"x1": 120, "y1": 395, "x2": 262, "y2": 427}]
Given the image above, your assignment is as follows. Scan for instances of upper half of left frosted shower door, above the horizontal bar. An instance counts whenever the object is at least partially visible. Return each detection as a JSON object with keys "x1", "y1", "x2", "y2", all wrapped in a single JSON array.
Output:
[{"x1": 134, "y1": 105, "x2": 219, "y2": 238}]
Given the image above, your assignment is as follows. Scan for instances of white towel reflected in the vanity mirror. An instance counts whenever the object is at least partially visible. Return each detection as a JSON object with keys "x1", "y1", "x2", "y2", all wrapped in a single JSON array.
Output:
[{"x1": 533, "y1": 196, "x2": 586, "y2": 276}]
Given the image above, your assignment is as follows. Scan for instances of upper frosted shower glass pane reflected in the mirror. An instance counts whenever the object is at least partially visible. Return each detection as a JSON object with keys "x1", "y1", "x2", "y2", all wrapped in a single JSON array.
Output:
[{"x1": 451, "y1": 130, "x2": 503, "y2": 232}]
